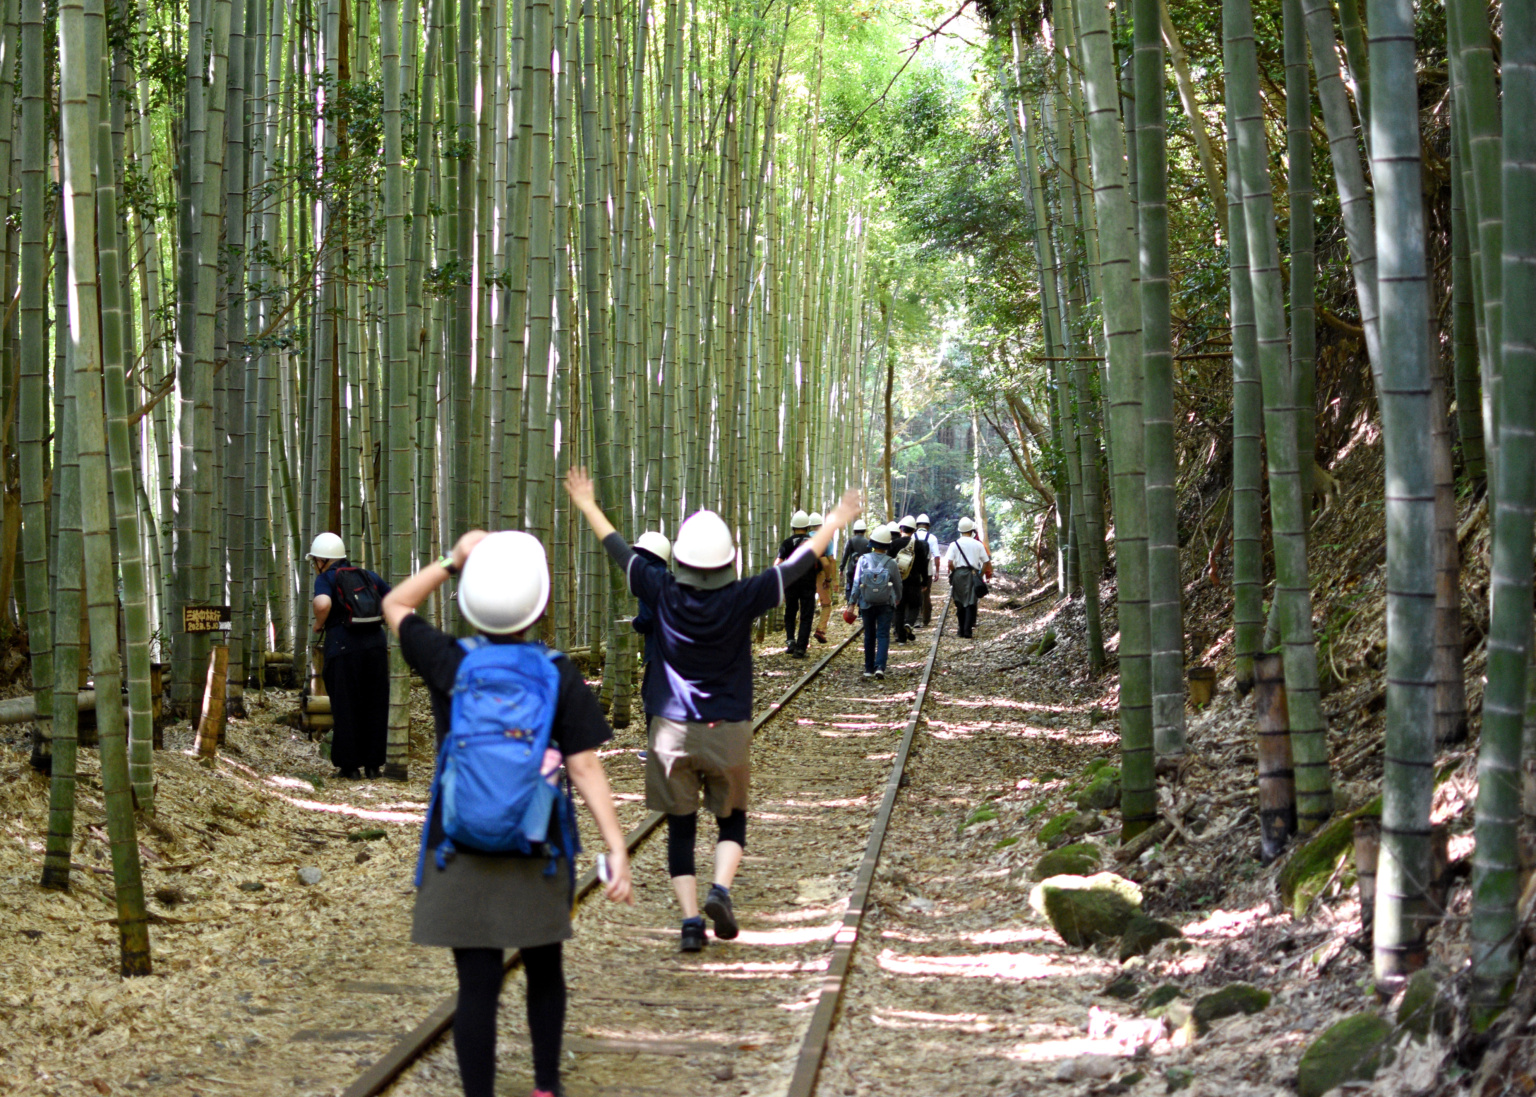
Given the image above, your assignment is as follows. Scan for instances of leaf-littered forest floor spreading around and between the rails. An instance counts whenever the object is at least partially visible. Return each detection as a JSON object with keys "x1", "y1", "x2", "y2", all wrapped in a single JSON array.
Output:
[{"x1": 0, "y1": 417, "x2": 1536, "y2": 1097}]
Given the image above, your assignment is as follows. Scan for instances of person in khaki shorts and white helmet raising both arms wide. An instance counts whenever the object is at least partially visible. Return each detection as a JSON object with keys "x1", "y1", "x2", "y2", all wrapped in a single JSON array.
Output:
[{"x1": 565, "y1": 469, "x2": 859, "y2": 953}]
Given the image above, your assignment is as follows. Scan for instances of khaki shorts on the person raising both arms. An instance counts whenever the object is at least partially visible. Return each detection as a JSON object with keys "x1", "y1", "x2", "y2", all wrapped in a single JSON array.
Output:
[{"x1": 645, "y1": 716, "x2": 753, "y2": 816}]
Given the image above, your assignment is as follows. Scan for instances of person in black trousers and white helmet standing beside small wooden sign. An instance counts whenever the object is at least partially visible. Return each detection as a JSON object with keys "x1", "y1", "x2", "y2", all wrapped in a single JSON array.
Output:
[{"x1": 309, "y1": 533, "x2": 389, "y2": 779}]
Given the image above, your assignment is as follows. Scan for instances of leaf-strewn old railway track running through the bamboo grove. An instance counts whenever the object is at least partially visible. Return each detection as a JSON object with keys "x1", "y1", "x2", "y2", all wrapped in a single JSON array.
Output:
[{"x1": 351, "y1": 598, "x2": 949, "y2": 1097}]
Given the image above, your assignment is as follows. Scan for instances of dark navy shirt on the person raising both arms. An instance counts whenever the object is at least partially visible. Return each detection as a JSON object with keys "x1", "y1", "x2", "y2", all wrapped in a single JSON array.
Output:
[{"x1": 602, "y1": 533, "x2": 814, "y2": 724}]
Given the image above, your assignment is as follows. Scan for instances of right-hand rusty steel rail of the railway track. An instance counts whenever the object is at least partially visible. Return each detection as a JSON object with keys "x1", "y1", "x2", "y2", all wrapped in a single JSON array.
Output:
[{"x1": 786, "y1": 593, "x2": 954, "y2": 1097}]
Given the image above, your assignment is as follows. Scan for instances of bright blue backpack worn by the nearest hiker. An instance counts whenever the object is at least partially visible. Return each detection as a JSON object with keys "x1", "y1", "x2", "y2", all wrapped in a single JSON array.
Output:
[{"x1": 416, "y1": 636, "x2": 581, "y2": 887}]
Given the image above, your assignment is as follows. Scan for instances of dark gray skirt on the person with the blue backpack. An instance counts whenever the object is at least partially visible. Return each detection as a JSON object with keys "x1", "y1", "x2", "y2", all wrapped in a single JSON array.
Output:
[{"x1": 410, "y1": 850, "x2": 571, "y2": 948}]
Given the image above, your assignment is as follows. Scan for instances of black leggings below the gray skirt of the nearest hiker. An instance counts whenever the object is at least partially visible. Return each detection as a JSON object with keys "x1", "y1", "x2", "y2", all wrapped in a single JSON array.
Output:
[{"x1": 453, "y1": 942, "x2": 565, "y2": 1097}]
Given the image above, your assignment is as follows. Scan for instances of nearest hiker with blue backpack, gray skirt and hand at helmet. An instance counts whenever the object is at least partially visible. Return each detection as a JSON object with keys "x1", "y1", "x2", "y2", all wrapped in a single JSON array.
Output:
[{"x1": 384, "y1": 530, "x2": 634, "y2": 1097}]
